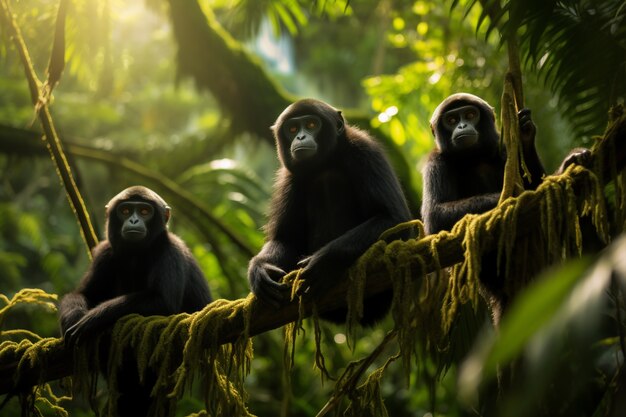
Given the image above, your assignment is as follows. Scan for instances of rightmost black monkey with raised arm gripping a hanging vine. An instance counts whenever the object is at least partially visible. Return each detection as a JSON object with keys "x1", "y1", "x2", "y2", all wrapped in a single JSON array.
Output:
[{"x1": 421, "y1": 93, "x2": 590, "y2": 323}]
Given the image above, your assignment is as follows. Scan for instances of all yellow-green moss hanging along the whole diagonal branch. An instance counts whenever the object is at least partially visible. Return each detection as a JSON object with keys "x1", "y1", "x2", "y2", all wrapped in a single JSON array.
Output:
[{"x1": 0, "y1": 108, "x2": 626, "y2": 416}]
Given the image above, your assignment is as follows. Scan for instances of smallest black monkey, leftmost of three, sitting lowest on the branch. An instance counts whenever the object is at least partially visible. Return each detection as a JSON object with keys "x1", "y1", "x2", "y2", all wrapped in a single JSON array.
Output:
[{"x1": 59, "y1": 186, "x2": 212, "y2": 416}]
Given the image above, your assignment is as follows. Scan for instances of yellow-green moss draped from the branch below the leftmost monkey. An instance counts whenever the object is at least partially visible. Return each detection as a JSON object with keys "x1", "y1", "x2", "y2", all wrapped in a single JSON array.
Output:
[{"x1": 65, "y1": 296, "x2": 252, "y2": 416}]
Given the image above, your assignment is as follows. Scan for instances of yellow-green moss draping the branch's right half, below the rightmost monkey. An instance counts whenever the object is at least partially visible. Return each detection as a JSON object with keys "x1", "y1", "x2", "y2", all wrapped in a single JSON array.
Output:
[{"x1": 318, "y1": 107, "x2": 626, "y2": 417}]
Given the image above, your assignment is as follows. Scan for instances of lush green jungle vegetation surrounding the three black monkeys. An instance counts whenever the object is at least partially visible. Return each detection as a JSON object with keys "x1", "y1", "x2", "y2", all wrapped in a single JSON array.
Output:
[{"x1": 0, "y1": 0, "x2": 626, "y2": 417}]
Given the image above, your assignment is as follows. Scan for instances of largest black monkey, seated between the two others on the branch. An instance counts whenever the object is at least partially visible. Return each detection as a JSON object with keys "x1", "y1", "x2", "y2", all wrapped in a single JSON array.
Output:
[{"x1": 248, "y1": 99, "x2": 411, "y2": 325}]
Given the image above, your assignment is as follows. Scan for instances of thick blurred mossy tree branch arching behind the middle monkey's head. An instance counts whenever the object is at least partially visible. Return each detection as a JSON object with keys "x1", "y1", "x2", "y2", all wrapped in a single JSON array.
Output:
[{"x1": 168, "y1": 0, "x2": 420, "y2": 210}]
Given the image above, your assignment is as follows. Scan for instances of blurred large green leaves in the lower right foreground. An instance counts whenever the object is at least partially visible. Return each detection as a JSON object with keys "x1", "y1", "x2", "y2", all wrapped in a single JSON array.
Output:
[{"x1": 460, "y1": 237, "x2": 626, "y2": 416}]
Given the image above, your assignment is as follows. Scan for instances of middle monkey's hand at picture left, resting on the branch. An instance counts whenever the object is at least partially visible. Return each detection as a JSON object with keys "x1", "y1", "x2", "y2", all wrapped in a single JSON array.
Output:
[{"x1": 248, "y1": 259, "x2": 291, "y2": 308}]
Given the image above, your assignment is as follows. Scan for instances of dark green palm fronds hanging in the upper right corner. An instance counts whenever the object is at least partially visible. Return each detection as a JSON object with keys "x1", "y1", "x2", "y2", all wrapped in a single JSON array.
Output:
[{"x1": 470, "y1": 0, "x2": 626, "y2": 137}]
